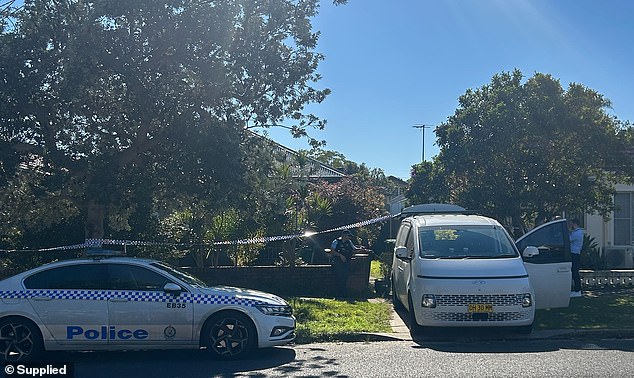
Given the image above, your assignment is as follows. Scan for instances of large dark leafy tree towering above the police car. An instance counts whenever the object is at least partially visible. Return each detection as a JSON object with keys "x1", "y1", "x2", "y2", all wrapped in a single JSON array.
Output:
[{"x1": 0, "y1": 0, "x2": 345, "y2": 244}]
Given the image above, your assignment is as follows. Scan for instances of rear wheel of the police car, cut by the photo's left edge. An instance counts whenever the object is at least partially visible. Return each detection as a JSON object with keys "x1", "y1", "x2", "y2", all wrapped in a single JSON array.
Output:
[{"x1": 0, "y1": 319, "x2": 43, "y2": 362}]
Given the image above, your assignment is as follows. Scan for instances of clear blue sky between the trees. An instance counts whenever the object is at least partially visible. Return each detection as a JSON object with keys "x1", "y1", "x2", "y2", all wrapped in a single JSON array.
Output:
[{"x1": 260, "y1": 0, "x2": 634, "y2": 179}]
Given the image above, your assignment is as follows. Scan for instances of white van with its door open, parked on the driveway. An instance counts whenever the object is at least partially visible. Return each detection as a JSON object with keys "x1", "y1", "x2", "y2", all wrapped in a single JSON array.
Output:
[{"x1": 392, "y1": 204, "x2": 571, "y2": 333}]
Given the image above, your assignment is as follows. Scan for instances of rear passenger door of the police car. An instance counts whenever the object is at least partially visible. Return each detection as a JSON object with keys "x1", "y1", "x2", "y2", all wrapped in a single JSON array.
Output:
[{"x1": 23, "y1": 262, "x2": 108, "y2": 348}]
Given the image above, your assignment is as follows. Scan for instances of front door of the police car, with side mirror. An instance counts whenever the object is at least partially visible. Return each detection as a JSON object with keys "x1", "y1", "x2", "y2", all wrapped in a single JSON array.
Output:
[{"x1": 108, "y1": 263, "x2": 194, "y2": 346}]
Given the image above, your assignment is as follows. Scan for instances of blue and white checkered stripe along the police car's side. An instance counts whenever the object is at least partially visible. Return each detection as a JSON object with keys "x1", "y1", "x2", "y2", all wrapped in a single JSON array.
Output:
[{"x1": 0, "y1": 290, "x2": 265, "y2": 307}]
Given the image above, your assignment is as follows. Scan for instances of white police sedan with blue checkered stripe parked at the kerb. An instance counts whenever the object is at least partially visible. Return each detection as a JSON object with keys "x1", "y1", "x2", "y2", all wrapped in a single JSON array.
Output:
[{"x1": 0, "y1": 255, "x2": 295, "y2": 362}]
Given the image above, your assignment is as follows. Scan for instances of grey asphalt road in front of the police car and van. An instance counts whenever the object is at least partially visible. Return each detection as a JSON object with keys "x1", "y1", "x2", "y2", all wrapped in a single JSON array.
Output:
[{"x1": 8, "y1": 338, "x2": 634, "y2": 378}]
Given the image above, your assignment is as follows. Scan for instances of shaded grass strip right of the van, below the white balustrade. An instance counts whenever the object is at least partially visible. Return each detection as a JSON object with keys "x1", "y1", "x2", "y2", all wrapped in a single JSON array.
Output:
[{"x1": 535, "y1": 292, "x2": 634, "y2": 329}]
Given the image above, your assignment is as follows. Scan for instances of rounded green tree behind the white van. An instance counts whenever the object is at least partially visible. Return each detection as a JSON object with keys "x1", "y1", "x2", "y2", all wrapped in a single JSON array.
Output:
[{"x1": 435, "y1": 70, "x2": 632, "y2": 230}]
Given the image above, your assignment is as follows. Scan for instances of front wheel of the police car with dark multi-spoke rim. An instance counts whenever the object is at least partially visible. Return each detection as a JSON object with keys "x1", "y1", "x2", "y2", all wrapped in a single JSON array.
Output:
[{"x1": 203, "y1": 312, "x2": 257, "y2": 359}]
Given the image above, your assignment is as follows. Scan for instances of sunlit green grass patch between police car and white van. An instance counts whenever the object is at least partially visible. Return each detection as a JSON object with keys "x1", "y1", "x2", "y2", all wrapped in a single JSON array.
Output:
[{"x1": 289, "y1": 298, "x2": 392, "y2": 344}]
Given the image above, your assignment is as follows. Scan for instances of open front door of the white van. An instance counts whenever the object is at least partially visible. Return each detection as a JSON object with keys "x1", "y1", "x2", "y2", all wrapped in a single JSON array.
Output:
[{"x1": 515, "y1": 219, "x2": 572, "y2": 309}]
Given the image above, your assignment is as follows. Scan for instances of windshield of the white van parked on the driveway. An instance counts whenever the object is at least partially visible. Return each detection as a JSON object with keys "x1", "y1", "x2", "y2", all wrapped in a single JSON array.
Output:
[{"x1": 419, "y1": 226, "x2": 519, "y2": 259}]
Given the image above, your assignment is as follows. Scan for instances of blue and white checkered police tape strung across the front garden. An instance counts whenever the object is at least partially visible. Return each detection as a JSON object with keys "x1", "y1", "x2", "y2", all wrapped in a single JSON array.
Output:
[{"x1": 0, "y1": 214, "x2": 400, "y2": 252}]
